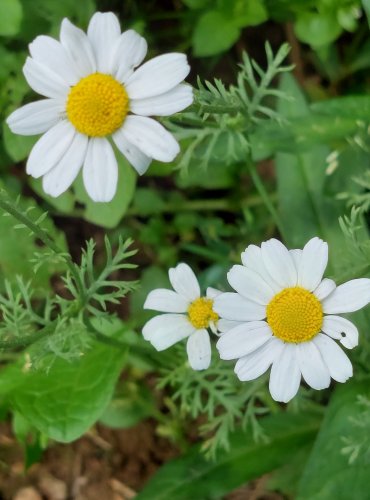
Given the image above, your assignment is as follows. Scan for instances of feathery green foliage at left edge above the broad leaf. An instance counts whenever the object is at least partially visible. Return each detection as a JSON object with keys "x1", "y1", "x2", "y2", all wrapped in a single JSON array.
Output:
[{"x1": 0, "y1": 190, "x2": 137, "y2": 357}]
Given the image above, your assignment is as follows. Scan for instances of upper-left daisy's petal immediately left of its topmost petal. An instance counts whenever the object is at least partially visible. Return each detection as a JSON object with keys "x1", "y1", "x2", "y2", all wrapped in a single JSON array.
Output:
[{"x1": 60, "y1": 19, "x2": 96, "y2": 78}]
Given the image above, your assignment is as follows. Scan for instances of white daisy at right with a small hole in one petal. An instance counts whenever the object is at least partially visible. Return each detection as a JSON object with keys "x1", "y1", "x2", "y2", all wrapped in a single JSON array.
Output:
[{"x1": 214, "y1": 238, "x2": 370, "y2": 403}]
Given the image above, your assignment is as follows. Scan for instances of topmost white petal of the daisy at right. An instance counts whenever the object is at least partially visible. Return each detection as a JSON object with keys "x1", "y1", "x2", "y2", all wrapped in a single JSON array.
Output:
[{"x1": 297, "y1": 238, "x2": 328, "y2": 292}]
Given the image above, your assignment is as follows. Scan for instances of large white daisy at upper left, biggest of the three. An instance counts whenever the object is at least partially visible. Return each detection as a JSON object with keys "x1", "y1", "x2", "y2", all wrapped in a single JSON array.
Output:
[{"x1": 7, "y1": 12, "x2": 193, "y2": 202}]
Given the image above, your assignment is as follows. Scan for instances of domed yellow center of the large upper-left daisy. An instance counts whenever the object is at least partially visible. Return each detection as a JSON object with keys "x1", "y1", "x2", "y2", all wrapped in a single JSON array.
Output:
[{"x1": 67, "y1": 73, "x2": 129, "y2": 137}]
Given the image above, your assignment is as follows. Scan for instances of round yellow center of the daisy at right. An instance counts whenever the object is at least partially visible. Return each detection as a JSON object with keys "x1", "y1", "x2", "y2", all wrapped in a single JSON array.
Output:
[{"x1": 267, "y1": 286, "x2": 323, "y2": 343}]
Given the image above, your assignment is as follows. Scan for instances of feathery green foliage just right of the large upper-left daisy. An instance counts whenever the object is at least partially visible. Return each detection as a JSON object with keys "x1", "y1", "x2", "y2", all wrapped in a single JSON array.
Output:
[{"x1": 166, "y1": 43, "x2": 292, "y2": 169}]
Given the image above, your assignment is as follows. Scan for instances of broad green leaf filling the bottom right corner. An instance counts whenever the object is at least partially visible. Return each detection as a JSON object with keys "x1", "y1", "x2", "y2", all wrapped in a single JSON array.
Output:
[{"x1": 297, "y1": 379, "x2": 370, "y2": 500}]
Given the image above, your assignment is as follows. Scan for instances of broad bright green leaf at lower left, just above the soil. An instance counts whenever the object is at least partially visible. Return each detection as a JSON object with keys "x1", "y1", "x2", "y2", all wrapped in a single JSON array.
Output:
[{"x1": 7, "y1": 332, "x2": 125, "y2": 443}]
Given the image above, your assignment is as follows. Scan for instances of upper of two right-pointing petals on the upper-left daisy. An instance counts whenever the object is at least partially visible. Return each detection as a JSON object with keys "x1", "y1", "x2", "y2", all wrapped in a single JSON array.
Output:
[{"x1": 125, "y1": 53, "x2": 190, "y2": 99}]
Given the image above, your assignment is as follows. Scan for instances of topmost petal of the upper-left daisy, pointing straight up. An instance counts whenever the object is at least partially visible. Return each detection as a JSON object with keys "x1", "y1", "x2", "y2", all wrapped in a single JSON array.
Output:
[{"x1": 87, "y1": 12, "x2": 121, "y2": 73}]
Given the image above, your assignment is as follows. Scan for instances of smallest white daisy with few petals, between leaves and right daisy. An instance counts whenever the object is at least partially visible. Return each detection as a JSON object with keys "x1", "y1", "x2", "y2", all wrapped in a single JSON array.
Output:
[{"x1": 143, "y1": 264, "x2": 220, "y2": 370}]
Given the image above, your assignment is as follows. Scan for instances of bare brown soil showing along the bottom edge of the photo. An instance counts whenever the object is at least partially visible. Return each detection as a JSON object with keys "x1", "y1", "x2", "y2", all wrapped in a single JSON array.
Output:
[{"x1": 0, "y1": 420, "x2": 282, "y2": 500}]
